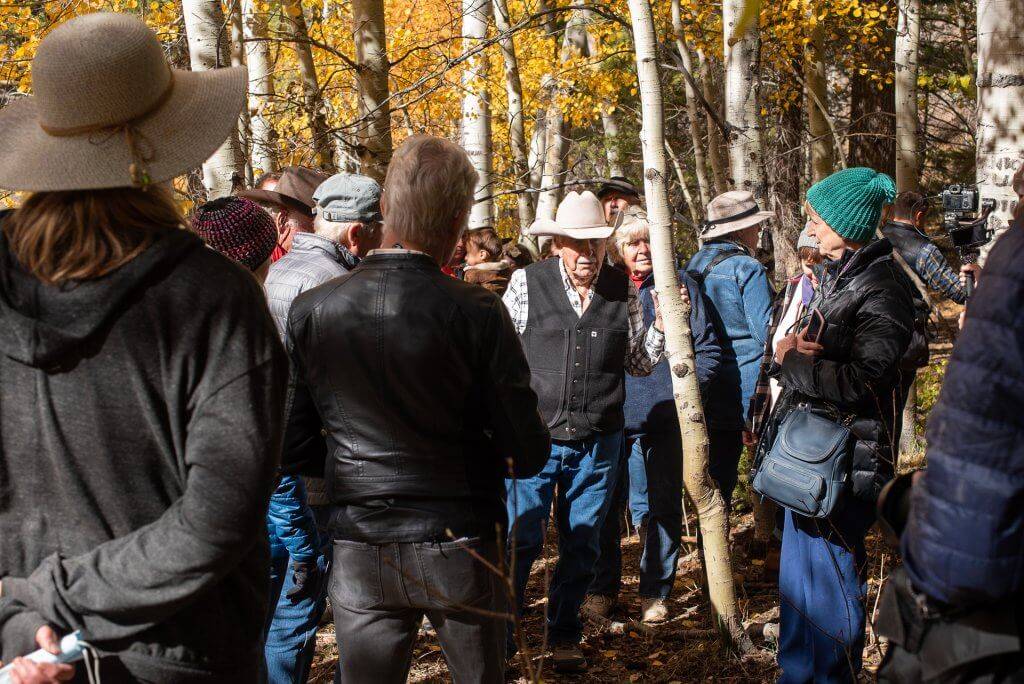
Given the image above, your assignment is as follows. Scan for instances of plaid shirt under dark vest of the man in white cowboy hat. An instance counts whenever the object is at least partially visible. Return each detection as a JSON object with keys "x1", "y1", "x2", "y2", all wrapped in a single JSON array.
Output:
[{"x1": 502, "y1": 257, "x2": 665, "y2": 376}]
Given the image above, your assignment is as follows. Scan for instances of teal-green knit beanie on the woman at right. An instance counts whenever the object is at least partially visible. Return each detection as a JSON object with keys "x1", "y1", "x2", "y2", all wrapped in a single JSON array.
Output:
[{"x1": 807, "y1": 167, "x2": 896, "y2": 243}]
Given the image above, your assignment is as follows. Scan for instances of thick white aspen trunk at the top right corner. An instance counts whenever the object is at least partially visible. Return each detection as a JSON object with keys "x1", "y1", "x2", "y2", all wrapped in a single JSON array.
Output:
[{"x1": 975, "y1": 0, "x2": 1024, "y2": 259}]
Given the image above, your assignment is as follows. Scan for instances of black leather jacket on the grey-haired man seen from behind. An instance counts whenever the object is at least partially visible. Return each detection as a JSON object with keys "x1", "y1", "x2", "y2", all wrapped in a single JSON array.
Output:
[{"x1": 283, "y1": 252, "x2": 550, "y2": 544}]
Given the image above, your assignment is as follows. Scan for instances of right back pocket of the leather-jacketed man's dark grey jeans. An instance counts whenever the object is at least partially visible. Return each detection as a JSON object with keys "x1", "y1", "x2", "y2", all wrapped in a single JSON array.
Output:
[{"x1": 417, "y1": 537, "x2": 497, "y2": 609}]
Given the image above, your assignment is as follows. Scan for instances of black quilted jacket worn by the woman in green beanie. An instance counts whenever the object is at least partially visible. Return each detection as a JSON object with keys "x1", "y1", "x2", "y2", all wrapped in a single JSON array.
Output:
[{"x1": 770, "y1": 240, "x2": 913, "y2": 506}]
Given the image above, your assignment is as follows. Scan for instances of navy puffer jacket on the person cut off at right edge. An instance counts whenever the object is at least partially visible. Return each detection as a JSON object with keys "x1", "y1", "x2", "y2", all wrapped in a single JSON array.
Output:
[{"x1": 902, "y1": 223, "x2": 1024, "y2": 606}]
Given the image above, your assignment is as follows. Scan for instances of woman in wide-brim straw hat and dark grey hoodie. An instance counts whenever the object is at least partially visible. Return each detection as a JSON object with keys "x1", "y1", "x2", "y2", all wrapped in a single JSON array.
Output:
[{"x1": 0, "y1": 13, "x2": 287, "y2": 682}]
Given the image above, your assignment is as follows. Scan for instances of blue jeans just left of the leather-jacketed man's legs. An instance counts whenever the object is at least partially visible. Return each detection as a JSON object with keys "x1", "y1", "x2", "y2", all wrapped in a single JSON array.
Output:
[{"x1": 263, "y1": 506, "x2": 331, "y2": 684}]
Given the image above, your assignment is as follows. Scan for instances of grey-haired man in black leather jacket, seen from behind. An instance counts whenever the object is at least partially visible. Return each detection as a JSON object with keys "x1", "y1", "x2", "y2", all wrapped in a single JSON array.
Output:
[{"x1": 284, "y1": 136, "x2": 550, "y2": 682}]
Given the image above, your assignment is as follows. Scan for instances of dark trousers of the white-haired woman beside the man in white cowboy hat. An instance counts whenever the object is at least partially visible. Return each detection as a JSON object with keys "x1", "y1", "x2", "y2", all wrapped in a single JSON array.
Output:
[{"x1": 590, "y1": 430, "x2": 683, "y2": 598}]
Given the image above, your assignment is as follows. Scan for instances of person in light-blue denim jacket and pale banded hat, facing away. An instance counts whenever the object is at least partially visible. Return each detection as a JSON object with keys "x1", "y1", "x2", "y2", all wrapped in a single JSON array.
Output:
[{"x1": 686, "y1": 190, "x2": 774, "y2": 506}]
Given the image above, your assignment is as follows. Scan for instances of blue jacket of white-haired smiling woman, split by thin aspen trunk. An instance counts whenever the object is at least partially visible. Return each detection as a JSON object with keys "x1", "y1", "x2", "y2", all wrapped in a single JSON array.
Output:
[{"x1": 625, "y1": 271, "x2": 722, "y2": 437}]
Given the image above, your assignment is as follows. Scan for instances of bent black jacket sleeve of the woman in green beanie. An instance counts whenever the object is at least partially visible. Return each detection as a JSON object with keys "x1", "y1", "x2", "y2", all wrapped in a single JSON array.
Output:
[{"x1": 778, "y1": 291, "x2": 913, "y2": 405}]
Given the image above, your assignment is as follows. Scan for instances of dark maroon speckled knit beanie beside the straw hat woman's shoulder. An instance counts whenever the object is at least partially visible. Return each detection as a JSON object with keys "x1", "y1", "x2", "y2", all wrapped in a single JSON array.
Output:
[{"x1": 191, "y1": 197, "x2": 278, "y2": 270}]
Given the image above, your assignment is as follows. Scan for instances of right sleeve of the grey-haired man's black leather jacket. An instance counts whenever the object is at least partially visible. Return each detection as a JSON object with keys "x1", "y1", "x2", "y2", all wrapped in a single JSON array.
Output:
[{"x1": 482, "y1": 297, "x2": 551, "y2": 477}]
